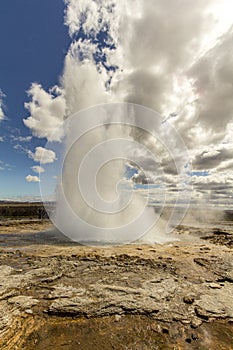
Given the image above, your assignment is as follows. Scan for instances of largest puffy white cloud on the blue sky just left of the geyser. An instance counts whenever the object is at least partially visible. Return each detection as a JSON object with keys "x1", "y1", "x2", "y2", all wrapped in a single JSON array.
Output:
[{"x1": 23, "y1": 83, "x2": 66, "y2": 141}]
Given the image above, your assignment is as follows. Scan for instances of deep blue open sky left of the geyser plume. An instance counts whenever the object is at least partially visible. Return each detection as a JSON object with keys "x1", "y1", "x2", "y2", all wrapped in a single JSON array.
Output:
[{"x1": 0, "y1": 0, "x2": 70, "y2": 199}]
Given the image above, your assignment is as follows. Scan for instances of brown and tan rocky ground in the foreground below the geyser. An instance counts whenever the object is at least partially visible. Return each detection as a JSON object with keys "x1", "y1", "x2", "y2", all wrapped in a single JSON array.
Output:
[{"x1": 0, "y1": 220, "x2": 233, "y2": 350}]
